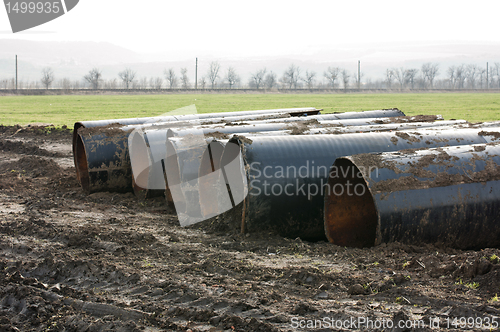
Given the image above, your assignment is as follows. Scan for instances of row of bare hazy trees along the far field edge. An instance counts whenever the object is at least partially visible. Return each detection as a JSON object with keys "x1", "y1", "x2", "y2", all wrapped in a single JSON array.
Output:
[{"x1": 0, "y1": 61, "x2": 500, "y2": 90}]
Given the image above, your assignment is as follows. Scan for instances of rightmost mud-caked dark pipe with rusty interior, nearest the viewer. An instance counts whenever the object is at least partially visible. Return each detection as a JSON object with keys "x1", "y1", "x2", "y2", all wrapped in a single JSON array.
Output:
[{"x1": 324, "y1": 143, "x2": 500, "y2": 249}]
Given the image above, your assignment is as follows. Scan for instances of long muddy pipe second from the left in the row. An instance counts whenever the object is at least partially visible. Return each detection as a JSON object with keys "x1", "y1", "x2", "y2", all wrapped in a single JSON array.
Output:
[{"x1": 128, "y1": 112, "x2": 426, "y2": 197}]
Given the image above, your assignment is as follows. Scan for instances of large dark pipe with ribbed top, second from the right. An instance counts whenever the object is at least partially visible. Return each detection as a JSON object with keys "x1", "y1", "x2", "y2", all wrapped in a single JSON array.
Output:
[{"x1": 223, "y1": 129, "x2": 500, "y2": 240}]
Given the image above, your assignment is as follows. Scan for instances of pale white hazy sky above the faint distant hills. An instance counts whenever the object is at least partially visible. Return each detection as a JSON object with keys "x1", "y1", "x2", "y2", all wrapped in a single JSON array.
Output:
[{"x1": 0, "y1": 0, "x2": 500, "y2": 58}]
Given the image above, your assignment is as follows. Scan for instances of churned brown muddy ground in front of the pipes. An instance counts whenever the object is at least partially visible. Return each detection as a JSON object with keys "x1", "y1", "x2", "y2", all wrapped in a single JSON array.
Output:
[{"x1": 0, "y1": 127, "x2": 500, "y2": 331}]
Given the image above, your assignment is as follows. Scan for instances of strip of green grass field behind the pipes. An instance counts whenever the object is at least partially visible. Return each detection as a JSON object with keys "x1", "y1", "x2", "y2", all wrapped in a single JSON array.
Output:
[{"x1": 0, "y1": 93, "x2": 500, "y2": 126}]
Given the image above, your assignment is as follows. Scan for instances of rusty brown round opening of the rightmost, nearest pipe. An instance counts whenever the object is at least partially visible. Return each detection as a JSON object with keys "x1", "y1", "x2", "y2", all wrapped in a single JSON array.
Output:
[{"x1": 324, "y1": 158, "x2": 378, "y2": 248}]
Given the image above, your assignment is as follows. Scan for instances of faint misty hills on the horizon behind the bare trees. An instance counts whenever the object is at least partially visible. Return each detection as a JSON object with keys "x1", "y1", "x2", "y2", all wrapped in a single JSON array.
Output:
[{"x1": 0, "y1": 39, "x2": 500, "y2": 84}]
